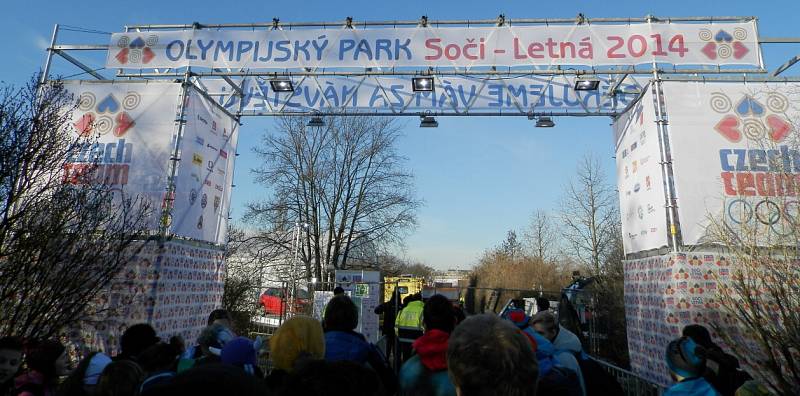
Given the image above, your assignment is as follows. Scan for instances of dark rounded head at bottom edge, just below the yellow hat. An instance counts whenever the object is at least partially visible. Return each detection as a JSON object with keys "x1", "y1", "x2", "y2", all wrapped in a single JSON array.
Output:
[{"x1": 285, "y1": 360, "x2": 385, "y2": 396}]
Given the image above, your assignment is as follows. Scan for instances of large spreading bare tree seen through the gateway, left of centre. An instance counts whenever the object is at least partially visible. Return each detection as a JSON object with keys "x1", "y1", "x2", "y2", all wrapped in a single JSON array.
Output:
[{"x1": 247, "y1": 116, "x2": 420, "y2": 279}]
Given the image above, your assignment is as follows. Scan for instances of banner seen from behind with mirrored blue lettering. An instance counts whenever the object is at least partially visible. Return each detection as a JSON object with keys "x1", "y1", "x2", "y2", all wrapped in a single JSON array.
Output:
[{"x1": 201, "y1": 76, "x2": 641, "y2": 114}]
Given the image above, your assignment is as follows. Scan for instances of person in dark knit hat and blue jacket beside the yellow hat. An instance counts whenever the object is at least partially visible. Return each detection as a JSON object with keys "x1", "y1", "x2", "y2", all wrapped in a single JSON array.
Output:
[{"x1": 323, "y1": 294, "x2": 397, "y2": 394}]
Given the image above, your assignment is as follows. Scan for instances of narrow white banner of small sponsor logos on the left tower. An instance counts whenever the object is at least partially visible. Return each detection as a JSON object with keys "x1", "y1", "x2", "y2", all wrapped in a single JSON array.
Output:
[{"x1": 172, "y1": 89, "x2": 239, "y2": 244}]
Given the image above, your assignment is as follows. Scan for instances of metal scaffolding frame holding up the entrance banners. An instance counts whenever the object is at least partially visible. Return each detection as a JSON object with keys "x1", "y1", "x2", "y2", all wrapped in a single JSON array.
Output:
[{"x1": 37, "y1": 14, "x2": 800, "y2": 251}]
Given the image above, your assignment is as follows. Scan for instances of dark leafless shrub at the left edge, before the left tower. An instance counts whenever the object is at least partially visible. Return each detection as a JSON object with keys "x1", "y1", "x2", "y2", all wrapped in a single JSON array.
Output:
[{"x1": 0, "y1": 79, "x2": 149, "y2": 337}]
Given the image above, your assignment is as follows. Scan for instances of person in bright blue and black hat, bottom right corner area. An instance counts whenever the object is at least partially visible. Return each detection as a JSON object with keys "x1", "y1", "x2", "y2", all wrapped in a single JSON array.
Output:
[{"x1": 664, "y1": 337, "x2": 719, "y2": 396}]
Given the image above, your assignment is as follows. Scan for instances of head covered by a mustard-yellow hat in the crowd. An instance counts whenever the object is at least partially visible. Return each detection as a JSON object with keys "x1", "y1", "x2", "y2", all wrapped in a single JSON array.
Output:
[{"x1": 269, "y1": 316, "x2": 325, "y2": 372}]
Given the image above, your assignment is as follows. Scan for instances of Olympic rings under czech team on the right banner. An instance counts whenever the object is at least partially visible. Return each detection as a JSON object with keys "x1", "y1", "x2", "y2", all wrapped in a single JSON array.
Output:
[{"x1": 725, "y1": 198, "x2": 800, "y2": 236}]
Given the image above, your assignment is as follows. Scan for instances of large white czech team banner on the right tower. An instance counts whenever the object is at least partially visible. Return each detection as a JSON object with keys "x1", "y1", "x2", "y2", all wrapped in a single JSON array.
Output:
[{"x1": 664, "y1": 82, "x2": 800, "y2": 245}]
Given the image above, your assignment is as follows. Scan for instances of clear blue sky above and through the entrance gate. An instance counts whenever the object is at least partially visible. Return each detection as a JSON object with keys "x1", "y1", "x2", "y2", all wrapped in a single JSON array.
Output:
[{"x1": 0, "y1": 0, "x2": 800, "y2": 268}]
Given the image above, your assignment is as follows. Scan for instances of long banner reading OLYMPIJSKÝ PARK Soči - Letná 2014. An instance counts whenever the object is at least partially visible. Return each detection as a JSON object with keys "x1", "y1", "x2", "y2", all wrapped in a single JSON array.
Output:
[{"x1": 106, "y1": 21, "x2": 761, "y2": 69}]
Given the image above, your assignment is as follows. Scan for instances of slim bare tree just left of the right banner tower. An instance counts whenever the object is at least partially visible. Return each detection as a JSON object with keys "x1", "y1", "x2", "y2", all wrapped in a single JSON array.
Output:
[{"x1": 561, "y1": 155, "x2": 619, "y2": 274}]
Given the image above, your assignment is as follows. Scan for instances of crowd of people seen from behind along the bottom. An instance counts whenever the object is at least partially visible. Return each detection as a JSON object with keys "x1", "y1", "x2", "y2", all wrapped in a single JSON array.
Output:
[{"x1": 0, "y1": 293, "x2": 765, "y2": 396}]
